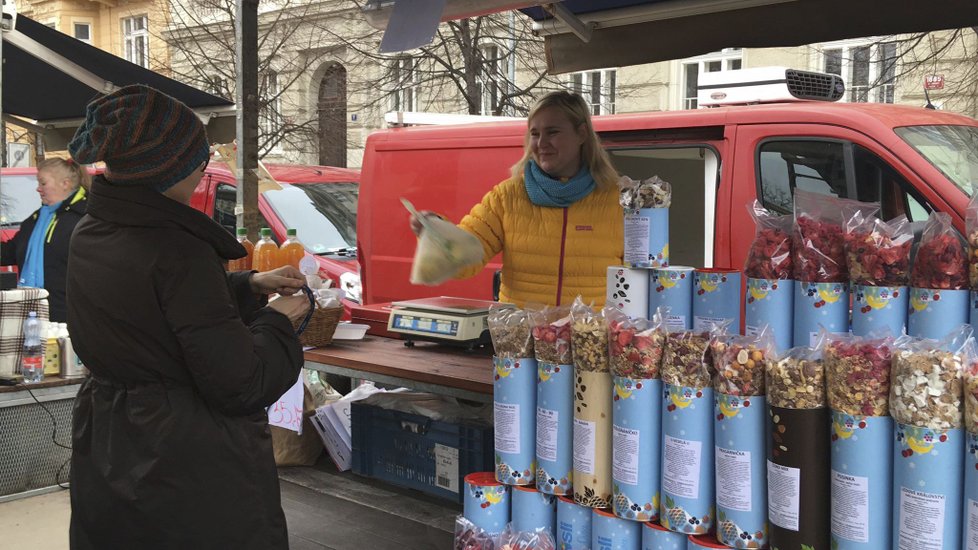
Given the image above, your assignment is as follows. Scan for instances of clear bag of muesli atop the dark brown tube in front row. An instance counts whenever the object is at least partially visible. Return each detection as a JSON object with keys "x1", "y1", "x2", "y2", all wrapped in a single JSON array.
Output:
[{"x1": 765, "y1": 346, "x2": 826, "y2": 409}]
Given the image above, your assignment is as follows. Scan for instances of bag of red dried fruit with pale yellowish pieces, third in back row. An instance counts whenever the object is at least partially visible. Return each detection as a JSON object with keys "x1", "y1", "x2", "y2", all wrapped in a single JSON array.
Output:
[{"x1": 845, "y1": 231, "x2": 913, "y2": 286}]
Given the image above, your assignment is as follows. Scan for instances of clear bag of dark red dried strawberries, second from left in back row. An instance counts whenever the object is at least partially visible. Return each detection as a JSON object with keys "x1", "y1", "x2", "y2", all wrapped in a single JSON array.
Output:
[{"x1": 793, "y1": 214, "x2": 849, "y2": 283}]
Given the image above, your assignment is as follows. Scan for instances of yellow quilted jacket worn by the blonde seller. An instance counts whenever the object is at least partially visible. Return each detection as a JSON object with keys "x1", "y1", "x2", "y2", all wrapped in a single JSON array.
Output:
[{"x1": 459, "y1": 177, "x2": 624, "y2": 307}]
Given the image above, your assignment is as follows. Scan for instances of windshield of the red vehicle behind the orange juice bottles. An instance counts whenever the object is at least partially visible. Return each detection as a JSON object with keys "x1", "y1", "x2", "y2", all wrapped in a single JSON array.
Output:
[{"x1": 262, "y1": 182, "x2": 359, "y2": 254}]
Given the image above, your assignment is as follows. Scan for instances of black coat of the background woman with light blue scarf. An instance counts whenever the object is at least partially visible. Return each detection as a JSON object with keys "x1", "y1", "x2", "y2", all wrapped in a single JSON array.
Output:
[{"x1": 0, "y1": 187, "x2": 88, "y2": 323}]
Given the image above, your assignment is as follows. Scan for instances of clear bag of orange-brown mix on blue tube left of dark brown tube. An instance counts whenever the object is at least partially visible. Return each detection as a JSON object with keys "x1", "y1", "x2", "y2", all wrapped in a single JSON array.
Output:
[{"x1": 713, "y1": 325, "x2": 775, "y2": 397}]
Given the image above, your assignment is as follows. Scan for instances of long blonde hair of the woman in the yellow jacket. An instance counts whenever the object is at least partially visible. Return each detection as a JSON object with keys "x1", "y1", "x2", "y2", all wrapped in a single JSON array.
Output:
[{"x1": 512, "y1": 91, "x2": 618, "y2": 186}]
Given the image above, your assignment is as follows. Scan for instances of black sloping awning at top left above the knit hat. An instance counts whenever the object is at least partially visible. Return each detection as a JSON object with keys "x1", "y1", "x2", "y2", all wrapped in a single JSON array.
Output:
[{"x1": 3, "y1": 15, "x2": 233, "y2": 121}]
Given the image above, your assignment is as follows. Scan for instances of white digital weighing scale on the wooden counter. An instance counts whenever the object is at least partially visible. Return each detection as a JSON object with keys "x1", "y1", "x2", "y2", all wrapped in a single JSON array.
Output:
[{"x1": 387, "y1": 296, "x2": 499, "y2": 350}]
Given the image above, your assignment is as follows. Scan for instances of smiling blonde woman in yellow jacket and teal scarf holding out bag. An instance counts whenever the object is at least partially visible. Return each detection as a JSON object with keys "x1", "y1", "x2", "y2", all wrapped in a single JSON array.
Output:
[{"x1": 411, "y1": 91, "x2": 624, "y2": 307}]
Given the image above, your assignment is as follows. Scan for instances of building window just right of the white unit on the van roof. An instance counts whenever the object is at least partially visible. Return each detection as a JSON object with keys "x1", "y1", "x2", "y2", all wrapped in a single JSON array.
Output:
[{"x1": 822, "y1": 42, "x2": 897, "y2": 103}]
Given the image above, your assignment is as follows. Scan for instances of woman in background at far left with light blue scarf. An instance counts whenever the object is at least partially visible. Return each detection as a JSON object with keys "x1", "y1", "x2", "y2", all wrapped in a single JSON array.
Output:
[{"x1": 0, "y1": 158, "x2": 90, "y2": 323}]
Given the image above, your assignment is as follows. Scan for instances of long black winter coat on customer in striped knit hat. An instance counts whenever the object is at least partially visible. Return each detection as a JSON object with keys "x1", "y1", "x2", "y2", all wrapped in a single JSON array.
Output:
[{"x1": 68, "y1": 178, "x2": 302, "y2": 550}]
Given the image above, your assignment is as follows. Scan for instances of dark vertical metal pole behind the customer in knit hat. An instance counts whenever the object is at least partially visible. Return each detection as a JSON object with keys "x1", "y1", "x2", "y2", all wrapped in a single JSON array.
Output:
[{"x1": 234, "y1": 0, "x2": 258, "y2": 242}]
